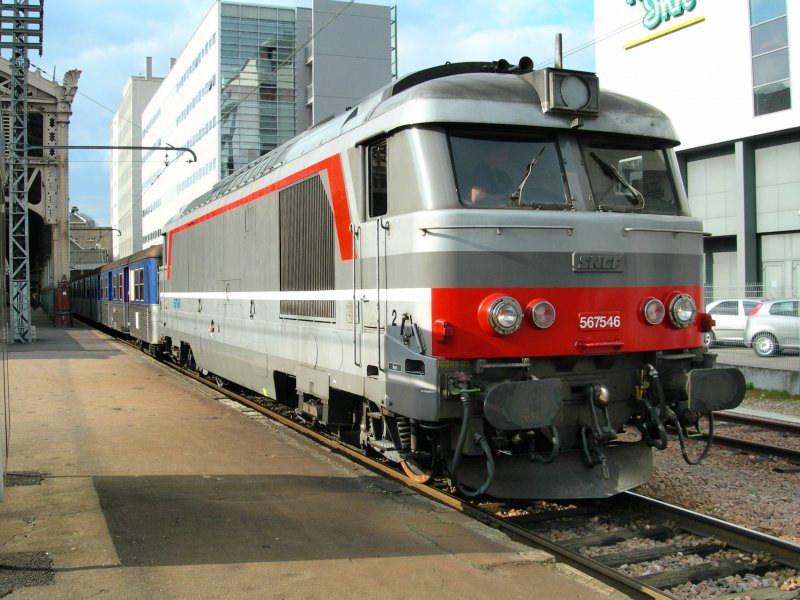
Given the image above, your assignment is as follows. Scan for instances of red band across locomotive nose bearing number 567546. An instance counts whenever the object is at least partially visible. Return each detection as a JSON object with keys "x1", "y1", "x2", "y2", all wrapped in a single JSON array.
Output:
[{"x1": 431, "y1": 286, "x2": 702, "y2": 358}]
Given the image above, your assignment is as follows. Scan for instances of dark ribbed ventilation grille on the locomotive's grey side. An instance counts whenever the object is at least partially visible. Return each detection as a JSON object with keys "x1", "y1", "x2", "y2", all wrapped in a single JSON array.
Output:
[{"x1": 279, "y1": 175, "x2": 336, "y2": 319}]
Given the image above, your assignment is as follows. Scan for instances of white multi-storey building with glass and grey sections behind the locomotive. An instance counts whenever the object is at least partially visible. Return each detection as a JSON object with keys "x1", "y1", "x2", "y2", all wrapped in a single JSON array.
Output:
[{"x1": 141, "y1": 0, "x2": 393, "y2": 247}]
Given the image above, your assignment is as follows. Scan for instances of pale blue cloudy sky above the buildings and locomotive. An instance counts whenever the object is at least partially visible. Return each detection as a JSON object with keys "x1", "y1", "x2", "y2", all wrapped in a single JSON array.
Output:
[{"x1": 15, "y1": 0, "x2": 595, "y2": 225}]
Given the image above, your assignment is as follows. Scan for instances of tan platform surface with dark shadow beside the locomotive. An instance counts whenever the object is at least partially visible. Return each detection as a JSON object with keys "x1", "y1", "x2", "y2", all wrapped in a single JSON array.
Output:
[{"x1": 0, "y1": 319, "x2": 621, "y2": 600}]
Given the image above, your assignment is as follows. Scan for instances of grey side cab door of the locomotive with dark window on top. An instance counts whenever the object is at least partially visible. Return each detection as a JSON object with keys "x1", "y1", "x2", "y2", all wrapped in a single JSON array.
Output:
[{"x1": 354, "y1": 140, "x2": 389, "y2": 377}]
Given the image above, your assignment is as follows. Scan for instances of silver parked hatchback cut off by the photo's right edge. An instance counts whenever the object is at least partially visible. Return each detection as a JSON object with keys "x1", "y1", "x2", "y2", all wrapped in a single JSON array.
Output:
[{"x1": 744, "y1": 298, "x2": 800, "y2": 356}]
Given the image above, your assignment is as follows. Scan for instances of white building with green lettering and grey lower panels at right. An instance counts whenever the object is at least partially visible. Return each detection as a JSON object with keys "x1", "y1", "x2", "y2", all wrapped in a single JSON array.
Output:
[{"x1": 595, "y1": 0, "x2": 800, "y2": 300}]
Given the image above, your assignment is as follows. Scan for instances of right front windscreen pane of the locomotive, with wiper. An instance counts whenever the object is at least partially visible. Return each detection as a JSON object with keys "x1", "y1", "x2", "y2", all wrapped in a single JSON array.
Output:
[{"x1": 582, "y1": 139, "x2": 680, "y2": 215}]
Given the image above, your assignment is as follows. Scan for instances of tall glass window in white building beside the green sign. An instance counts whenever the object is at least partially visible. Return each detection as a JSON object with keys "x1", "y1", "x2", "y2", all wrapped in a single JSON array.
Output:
[{"x1": 750, "y1": 0, "x2": 792, "y2": 116}]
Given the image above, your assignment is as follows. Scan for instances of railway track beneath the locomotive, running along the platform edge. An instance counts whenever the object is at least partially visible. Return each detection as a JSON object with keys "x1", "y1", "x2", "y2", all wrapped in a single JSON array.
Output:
[{"x1": 162, "y1": 356, "x2": 800, "y2": 600}]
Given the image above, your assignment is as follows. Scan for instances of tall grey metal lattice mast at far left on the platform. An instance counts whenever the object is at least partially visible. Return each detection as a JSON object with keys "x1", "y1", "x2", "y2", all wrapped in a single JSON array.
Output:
[{"x1": 0, "y1": 0, "x2": 44, "y2": 343}]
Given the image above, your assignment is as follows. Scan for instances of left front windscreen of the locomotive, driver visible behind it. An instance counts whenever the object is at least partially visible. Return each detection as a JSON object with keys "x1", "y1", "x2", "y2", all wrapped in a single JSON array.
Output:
[{"x1": 449, "y1": 134, "x2": 568, "y2": 209}]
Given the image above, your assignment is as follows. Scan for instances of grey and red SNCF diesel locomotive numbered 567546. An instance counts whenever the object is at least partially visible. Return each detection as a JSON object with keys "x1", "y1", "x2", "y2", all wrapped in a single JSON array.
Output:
[{"x1": 72, "y1": 58, "x2": 744, "y2": 498}]
